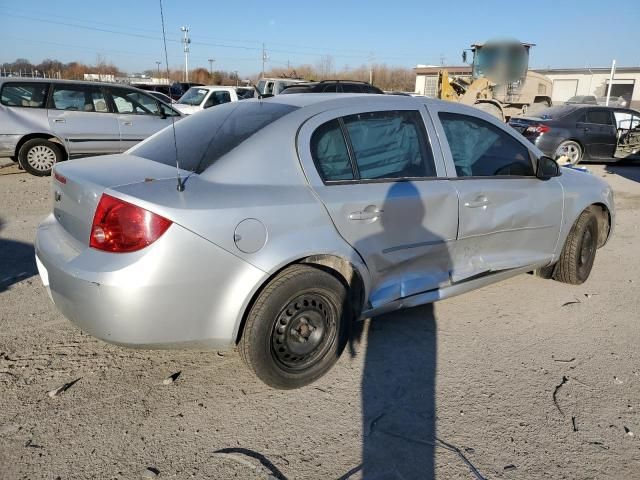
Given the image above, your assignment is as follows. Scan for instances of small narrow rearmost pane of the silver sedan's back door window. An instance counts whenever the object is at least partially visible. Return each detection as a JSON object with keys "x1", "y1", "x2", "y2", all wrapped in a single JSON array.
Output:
[{"x1": 311, "y1": 120, "x2": 354, "y2": 181}]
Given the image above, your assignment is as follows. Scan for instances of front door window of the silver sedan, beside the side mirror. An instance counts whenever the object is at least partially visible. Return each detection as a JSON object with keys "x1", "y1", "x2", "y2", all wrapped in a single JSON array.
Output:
[{"x1": 439, "y1": 112, "x2": 534, "y2": 177}]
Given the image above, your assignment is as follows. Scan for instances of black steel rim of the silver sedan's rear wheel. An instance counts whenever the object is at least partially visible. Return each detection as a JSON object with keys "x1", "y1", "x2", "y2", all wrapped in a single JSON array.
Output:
[{"x1": 271, "y1": 292, "x2": 338, "y2": 371}]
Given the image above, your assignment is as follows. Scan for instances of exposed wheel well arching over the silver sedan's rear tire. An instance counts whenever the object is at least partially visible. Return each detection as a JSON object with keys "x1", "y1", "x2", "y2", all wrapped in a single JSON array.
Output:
[{"x1": 235, "y1": 254, "x2": 364, "y2": 344}]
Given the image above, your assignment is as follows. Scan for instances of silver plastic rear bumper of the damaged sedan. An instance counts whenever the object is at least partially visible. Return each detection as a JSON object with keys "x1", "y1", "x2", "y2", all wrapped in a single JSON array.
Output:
[{"x1": 35, "y1": 215, "x2": 266, "y2": 348}]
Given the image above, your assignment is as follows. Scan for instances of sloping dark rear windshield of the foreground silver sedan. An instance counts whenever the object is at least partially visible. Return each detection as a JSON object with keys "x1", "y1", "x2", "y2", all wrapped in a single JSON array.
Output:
[{"x1": 127, "y1": 100, "x2": 298, "y2": 173}]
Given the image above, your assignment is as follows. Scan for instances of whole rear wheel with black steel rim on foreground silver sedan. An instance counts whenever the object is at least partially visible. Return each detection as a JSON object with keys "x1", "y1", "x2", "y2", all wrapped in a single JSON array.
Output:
[{"x1": 238, "y1": 265, "x2": 352, "y2": 389}]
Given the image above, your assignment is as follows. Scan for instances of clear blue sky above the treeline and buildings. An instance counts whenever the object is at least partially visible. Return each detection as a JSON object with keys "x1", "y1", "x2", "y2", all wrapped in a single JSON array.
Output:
[{"x1": 0, "y1": 0, "x2": 640, "y2": 75}]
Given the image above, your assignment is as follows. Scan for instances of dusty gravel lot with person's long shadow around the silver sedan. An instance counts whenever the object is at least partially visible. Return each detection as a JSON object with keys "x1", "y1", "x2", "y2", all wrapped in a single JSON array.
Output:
[{"x1": 0, "y1": 159, "x2": 640, "y2": 479}]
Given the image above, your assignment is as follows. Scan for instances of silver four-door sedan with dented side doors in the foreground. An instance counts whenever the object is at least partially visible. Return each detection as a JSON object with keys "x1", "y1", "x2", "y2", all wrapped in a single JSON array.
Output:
[{"x1": 35, "y1": 94, "x2": 614, "y2": 388}]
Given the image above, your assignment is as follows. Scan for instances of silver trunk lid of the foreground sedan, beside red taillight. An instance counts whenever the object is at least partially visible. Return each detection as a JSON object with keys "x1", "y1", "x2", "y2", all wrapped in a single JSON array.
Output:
[{"x1": 51, "y1": 154, "x2": 184, "y2": 245}]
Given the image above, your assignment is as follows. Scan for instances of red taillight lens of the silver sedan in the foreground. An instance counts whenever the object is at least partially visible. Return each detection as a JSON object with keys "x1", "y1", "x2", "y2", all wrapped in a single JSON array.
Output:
[{"x1": 89, "y1": 194, "x2": 171, "y2": 253}]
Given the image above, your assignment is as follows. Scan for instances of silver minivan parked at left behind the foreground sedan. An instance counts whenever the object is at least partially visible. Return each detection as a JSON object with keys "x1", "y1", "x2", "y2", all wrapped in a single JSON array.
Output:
[{"x1": 0, "y1": 78, "x2": 181, "y2": 176}]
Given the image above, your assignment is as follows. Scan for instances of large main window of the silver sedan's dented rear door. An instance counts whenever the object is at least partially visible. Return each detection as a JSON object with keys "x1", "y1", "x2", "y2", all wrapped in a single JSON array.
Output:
[{"x1": 344, "y1": 111, "x2": 436, "y2": 180}]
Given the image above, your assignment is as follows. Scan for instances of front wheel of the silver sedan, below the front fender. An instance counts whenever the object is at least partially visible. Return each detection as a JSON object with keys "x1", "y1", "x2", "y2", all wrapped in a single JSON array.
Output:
[{"x1": 554, "y1": 209, "x2": 598, "y2": 285}]
